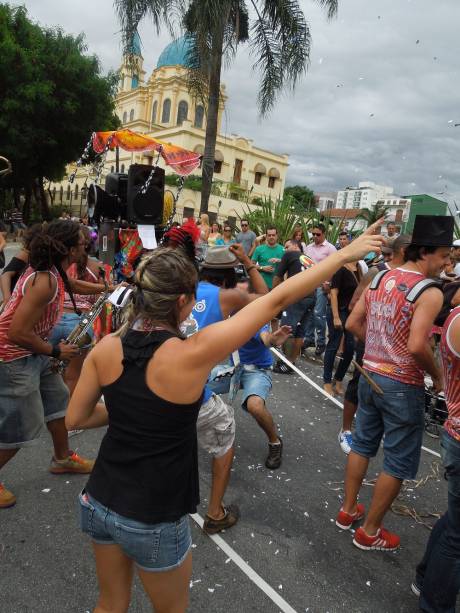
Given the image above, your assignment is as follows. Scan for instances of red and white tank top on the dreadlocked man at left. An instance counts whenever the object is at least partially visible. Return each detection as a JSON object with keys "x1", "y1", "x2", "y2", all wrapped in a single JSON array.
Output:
[{"x1": 0, "y1": 266, "x2": 65, "y2": 362}]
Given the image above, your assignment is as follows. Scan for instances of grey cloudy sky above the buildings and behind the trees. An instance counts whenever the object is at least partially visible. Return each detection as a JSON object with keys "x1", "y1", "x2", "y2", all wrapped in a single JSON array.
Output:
[{"x1": 18, "y1": 0, "x2": 460, "y2": 204}]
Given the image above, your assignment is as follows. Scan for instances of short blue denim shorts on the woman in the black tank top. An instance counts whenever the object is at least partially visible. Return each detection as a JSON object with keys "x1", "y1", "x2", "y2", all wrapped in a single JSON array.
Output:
[{"x1": 79, "y1": 490, "x2": 192, "y2": 572}]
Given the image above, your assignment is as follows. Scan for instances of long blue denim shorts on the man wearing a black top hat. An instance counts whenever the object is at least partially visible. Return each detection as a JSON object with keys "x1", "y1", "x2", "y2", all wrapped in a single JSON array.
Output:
[{"x1": 351, "y1": 371, "x2": 425, "y2": 479}]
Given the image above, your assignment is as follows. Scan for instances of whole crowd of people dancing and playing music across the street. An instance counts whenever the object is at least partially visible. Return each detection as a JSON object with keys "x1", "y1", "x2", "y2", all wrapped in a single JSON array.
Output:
[{"x1": 0, "y1": 215, "x2": 460, "y2": 613}]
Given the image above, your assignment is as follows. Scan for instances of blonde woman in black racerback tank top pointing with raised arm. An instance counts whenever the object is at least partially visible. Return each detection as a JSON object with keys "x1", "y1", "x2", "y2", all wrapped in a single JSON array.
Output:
[{"x1": 66, "y1": 226, "x2": 381, "y2": 613}]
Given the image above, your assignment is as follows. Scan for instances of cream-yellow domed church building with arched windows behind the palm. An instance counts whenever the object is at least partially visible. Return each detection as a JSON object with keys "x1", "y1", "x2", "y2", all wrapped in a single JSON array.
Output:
[{"x1": 52, "y1": 37, "x2": 288, "y2": 219}]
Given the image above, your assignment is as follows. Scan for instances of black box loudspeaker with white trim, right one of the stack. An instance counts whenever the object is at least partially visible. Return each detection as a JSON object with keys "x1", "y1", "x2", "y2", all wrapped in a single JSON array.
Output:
[{"x1": 128, "y1": 164, "x2": 165, "y2": 226}]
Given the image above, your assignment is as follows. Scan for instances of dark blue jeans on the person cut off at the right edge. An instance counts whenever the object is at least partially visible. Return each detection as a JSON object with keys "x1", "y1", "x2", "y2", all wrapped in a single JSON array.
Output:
[{"x1": 416, "y1": 431, "x2": 460, "y2": 613}]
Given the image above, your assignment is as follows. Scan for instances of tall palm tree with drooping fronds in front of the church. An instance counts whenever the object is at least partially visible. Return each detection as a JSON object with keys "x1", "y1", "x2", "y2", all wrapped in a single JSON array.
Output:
[{"x1": 114, "y1": 0, "x2": 338, "y2": 212}]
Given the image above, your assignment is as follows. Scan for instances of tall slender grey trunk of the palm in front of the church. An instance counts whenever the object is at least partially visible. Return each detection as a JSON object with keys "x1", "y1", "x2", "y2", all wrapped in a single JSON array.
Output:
[{"x1": 200, "y1": 24, "x2": 224, "y2": 213}]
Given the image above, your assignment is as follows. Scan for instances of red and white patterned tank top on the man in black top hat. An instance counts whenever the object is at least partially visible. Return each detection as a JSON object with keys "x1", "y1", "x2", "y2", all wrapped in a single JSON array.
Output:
[{"x1": 363, "y1": 268, "x2": 428, "y2": 386}]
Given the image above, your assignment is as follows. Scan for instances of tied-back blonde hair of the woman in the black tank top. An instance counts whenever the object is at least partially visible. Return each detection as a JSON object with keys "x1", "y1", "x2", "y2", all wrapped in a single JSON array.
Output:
[{"x1": 118, "y1": 247, "x2": 198, "y2": 335}]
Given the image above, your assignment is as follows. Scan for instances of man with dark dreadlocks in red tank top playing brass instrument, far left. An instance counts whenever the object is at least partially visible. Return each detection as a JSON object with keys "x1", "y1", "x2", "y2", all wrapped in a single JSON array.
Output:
[{"x1": 0, "y1": 220, "x2": 93, "y2": 508}]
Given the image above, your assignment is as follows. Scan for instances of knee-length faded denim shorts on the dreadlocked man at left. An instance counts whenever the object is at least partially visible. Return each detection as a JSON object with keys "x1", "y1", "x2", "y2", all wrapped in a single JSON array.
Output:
[{"x1": 0, "y1": 355, "x2": 69, "y2": 449}]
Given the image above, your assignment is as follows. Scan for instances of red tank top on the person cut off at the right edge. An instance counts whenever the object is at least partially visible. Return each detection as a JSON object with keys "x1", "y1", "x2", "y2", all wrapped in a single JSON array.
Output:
[{"x1": 440, "y1": 306, "x2": 460, "y2": 441}]
